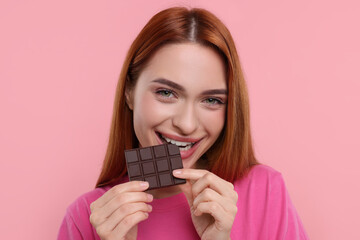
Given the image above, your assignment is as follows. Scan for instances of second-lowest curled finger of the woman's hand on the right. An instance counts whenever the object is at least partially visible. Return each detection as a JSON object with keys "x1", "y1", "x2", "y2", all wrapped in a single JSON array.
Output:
[{"x1": 193, "y1": 188, "x2": 237, "y2": 213}]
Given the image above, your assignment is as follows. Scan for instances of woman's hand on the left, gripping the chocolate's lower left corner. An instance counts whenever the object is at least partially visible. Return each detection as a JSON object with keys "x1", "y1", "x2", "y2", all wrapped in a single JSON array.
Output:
[{"x1": 90, "y1": 181, "x2": 153, "y2": 240}]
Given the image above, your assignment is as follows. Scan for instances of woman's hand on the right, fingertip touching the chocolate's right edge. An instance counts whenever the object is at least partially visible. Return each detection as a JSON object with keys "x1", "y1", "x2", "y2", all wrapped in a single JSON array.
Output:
[{"x1": 173, "y1": 169, "x2": 238, "y2": 240}]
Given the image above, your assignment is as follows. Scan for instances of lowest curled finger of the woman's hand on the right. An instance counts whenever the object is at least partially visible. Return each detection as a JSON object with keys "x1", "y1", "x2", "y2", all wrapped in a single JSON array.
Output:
[{"x1": 194, "y1": 202, "x2": 234, "y2": 231}]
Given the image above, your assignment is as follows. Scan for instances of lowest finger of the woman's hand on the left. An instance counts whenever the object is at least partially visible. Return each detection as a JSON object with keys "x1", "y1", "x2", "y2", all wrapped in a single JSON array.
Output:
[{"x1": 113, "y1": 211, "x2": 149, "y2": 236}]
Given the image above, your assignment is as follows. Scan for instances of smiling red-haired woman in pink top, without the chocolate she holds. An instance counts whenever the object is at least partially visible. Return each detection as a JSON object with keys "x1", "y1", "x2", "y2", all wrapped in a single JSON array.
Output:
[{"x1": 58, "y1": 8, "x2": 307, "y2": 240}]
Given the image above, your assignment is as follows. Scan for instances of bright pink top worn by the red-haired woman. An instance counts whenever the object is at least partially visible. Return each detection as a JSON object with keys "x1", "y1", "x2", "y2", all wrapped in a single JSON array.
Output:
[{"x1": 58, "y1": 165, "x2": 309, "y2": 240}]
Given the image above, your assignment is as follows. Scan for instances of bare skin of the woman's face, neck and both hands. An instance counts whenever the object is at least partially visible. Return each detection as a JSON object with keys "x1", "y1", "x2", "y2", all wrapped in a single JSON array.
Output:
[{"x1": 90, "y1": 43, "x2": 238, "y2": 239}]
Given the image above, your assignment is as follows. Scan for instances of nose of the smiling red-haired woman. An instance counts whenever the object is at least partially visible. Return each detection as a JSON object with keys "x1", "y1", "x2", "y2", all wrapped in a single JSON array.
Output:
[{"x1": 172, "y1": 103, "x2": 199, "y2": 135}]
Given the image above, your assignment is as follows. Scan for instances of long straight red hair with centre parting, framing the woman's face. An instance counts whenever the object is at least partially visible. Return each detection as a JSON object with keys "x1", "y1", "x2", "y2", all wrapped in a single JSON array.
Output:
[{"x1": 96, "y1": 7, "x2": 258, "y2": 187}]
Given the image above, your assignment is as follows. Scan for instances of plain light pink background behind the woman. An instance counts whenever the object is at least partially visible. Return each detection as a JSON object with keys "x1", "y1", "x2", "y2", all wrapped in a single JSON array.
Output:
[{"x1": 0, "y1": 0, "x2": 360, "y2": 240}]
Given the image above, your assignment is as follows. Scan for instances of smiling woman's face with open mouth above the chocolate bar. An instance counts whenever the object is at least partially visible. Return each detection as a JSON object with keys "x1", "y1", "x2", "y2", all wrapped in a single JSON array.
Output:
[{"x1": 127, "y1": 43, "x2": 227, "y2": 168}]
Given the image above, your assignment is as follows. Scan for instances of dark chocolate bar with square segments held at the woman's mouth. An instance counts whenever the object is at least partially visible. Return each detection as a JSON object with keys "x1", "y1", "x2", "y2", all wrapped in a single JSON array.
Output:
[{"x1": 125, "y1": 144, "x2": 186, "y2": 190}]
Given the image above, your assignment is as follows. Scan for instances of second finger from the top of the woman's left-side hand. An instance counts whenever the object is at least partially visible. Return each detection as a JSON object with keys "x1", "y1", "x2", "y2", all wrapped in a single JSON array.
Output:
[{"x1": 90, "y1": 192, "x2": 153, "y2": 225}]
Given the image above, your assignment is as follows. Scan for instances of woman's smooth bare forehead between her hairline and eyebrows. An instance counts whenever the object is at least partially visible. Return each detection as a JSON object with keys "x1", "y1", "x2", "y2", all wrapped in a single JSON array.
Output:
[{"x1": 139, "y1": 43, "x2": 227, "y2": 88}]
